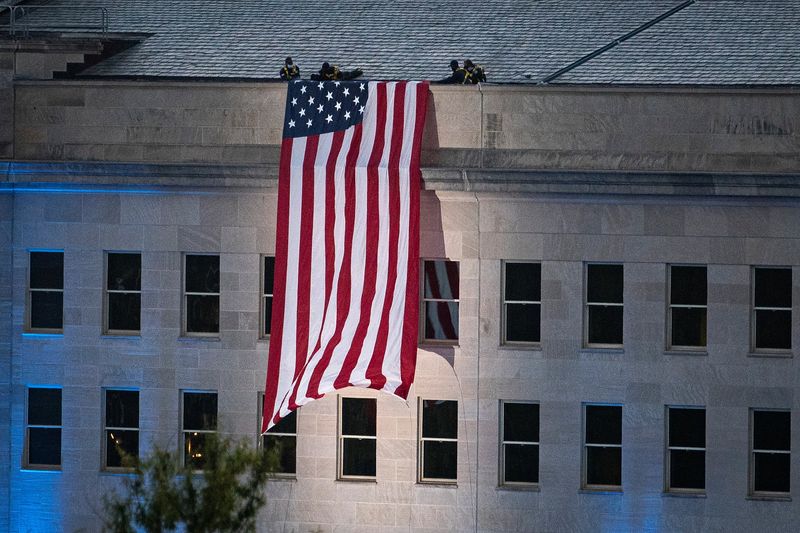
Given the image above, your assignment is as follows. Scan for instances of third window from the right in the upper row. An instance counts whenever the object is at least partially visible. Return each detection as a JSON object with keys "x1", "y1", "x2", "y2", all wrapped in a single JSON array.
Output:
[{"x1": 583, "y1": 264, "x2": 623, "y2": 347}]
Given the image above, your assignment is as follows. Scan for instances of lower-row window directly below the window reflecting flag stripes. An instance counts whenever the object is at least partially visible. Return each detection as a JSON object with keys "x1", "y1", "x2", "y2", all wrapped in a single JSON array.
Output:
[{"x1": 418, "y1": 399, "x2": 458, "y2": 483}]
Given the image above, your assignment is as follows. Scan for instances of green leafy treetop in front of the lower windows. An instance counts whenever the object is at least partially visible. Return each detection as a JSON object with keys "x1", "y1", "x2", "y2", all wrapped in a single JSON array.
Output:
[{"x1": 103, "y1": 434, "x2": 278, "y2": 533}]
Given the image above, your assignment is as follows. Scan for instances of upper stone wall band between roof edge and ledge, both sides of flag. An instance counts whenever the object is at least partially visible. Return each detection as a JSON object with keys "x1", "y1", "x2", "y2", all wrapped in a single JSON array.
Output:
[{"x1": 14, "y1": 80, "x2": 800, "y2": 173}]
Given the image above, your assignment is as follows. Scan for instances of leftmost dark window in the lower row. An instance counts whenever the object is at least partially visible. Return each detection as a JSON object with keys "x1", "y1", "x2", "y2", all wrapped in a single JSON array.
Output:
[{"x1": 25, "y1": 387, "x2": 61, "y2": 469}]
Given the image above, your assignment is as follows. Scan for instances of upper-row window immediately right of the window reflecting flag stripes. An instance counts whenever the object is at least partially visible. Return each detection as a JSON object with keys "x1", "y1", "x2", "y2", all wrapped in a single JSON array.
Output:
[{"x1": 503, "y1": 263, "x2": 542, "y2": 344}]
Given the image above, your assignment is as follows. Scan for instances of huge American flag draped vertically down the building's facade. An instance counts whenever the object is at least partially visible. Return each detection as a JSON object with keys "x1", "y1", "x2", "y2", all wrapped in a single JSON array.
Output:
[{"x1": 262, "y1": 80, "x2": 428, "y2": 431}]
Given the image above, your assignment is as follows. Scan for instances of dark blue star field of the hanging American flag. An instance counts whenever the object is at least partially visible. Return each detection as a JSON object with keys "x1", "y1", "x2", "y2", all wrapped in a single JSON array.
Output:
[{"x1": 283, "y1": 80, "x2": 369, "y2": 137}]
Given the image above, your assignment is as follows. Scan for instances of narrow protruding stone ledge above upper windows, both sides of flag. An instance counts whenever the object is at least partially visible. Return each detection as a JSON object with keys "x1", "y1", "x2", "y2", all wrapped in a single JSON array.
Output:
[{"x1": 0, "y1": 161, "x2": 800, "y2": 197}]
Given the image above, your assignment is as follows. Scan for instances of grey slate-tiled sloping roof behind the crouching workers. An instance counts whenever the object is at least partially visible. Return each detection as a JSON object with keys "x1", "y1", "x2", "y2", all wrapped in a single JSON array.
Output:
[{"x1": 10, "y1": 0, "x2": 800, "y2": 85}]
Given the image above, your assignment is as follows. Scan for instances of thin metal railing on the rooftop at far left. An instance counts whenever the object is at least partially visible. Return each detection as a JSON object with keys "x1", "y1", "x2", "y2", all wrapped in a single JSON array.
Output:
[{"x1": 0, "y1": 4, "x2": 108, "y2": 37}]
